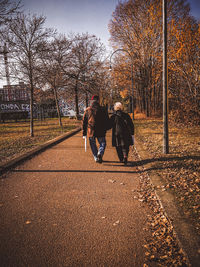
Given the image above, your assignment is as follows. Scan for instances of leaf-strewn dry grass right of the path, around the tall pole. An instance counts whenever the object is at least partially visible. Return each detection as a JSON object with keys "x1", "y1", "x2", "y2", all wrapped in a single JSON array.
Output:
[{"x1": 135, "y1": 119, "x2": 200, "y2": 233}]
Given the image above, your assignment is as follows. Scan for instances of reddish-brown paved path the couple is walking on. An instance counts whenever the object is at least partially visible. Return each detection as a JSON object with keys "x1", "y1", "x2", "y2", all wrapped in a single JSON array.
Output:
[{"x1": 0, "y1": 132, "x2": 153, "y2": 267}]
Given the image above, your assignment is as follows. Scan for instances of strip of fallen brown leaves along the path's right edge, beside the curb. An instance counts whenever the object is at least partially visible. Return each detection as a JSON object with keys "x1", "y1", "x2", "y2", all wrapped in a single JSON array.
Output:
[{"x1": 134, "y1": 160, "x2": 189, "y2": 267}]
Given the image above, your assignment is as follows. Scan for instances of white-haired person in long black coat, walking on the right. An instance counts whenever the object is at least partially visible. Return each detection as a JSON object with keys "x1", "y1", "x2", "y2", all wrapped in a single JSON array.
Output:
[{"x1": 110, "y1": 102, "x2": 134, "y2": 165}]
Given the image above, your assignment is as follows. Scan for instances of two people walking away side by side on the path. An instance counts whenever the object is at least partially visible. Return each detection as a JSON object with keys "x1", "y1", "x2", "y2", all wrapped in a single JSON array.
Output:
[{"x1": 82, "y1": 95, "x2": 134, "y2": 165}]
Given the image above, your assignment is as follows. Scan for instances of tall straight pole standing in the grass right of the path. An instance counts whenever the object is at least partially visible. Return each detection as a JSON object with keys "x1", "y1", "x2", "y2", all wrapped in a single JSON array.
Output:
[{"x1": 163, "y1": 0, "x2": 169, "y2": 154}]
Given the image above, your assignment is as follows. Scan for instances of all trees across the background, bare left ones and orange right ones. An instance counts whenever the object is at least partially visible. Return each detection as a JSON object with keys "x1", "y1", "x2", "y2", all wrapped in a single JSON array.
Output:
[{"x1": 0, "y1": 0, "x2": 200, "y2": 136}]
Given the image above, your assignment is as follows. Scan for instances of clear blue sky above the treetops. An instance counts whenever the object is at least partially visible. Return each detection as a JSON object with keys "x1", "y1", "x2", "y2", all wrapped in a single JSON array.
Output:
[{"x1": 22, "y1": 0, "x2": 200, "y2": 51}]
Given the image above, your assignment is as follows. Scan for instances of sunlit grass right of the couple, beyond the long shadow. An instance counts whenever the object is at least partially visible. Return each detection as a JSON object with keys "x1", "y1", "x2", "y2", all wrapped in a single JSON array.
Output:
[{"x1": 135, "y1": 119, "x2": 200, "y2": 155}]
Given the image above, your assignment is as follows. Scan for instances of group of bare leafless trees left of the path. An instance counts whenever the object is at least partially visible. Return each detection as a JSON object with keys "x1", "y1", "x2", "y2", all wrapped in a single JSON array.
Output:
[{"x1": 0, "y1": 0, "x2": 111, "y2": 136}]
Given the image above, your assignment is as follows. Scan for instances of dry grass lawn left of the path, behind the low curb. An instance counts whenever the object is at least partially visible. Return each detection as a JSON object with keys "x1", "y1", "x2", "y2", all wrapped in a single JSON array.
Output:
[{"x1": 0, "y1": 118, "x2": 80, "y2": 164}]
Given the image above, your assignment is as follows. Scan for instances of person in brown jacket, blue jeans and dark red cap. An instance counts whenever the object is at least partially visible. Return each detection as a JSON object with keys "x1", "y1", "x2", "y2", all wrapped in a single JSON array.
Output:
[{"x1": 82, "y1": 95, "x2": 109, "y2": 163}]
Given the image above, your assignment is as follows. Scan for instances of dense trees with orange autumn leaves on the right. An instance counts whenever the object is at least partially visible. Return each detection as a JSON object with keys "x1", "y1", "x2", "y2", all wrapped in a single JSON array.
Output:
[{"x1": 109, "y1": 0, "x2": 200, "y2": 124}]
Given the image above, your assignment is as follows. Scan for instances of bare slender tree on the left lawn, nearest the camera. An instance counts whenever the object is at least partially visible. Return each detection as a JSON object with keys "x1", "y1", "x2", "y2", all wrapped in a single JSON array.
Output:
[{"x1": 6, "y1": 14, "x2": 53, "y2": 136}]
